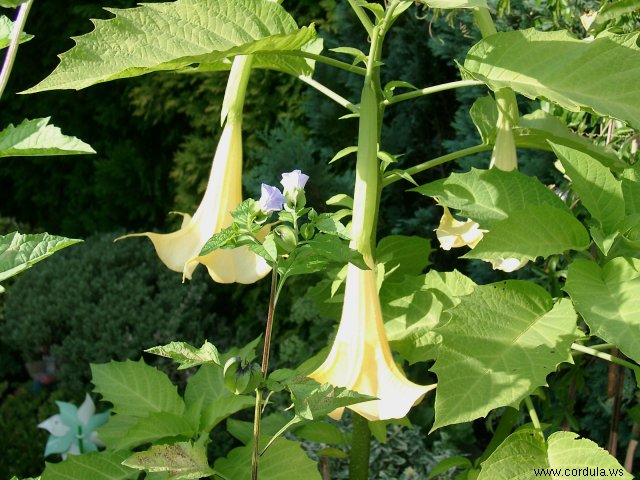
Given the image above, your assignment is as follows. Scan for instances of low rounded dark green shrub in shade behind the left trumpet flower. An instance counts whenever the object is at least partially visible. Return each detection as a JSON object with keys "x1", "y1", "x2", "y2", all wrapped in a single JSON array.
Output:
[{"x1": 0, "y1": 234, "x2": 225, "y2": 395}]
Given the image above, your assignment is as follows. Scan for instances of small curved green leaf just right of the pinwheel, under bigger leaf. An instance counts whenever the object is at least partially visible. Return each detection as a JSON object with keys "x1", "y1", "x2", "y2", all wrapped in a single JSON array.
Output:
[{"x1": 113, "y1": 412, "x2": 197, "y2": 450}]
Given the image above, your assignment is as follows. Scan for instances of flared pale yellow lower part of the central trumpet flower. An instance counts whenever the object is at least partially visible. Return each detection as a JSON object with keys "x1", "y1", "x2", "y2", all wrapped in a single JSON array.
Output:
[{"x1": 309, "y1": 264, "x2": 435, "y2": 420}]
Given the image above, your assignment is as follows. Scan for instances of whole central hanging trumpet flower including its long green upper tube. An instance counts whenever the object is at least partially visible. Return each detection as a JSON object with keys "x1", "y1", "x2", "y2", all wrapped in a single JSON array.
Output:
[{"x1": 310, "y1": 80, "x2": 435, "y2": 420}]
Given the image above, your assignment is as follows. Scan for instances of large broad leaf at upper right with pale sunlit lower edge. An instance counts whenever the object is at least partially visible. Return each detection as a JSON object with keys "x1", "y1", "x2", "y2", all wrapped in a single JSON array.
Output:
[{"x1": 464, "y1": 29, "x2": 640, "y2": 128}]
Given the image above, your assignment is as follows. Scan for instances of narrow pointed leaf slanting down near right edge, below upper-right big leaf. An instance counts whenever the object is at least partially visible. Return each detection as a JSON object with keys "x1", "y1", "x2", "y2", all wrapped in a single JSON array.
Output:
[{"x1": 551, "y1": 143, "x2": 625, "y2": 235}]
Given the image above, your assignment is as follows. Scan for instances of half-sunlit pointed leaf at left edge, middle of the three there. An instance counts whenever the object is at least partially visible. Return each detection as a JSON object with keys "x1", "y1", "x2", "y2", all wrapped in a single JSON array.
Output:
[{"x1": 0, "y1": 117, "x2": 96, "y2": 158}]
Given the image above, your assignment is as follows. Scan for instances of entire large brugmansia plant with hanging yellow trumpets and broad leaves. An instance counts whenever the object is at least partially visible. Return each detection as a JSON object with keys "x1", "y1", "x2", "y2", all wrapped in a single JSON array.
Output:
[{"x1": 8, "y1": 0, "x2": 640, "y2": 480}]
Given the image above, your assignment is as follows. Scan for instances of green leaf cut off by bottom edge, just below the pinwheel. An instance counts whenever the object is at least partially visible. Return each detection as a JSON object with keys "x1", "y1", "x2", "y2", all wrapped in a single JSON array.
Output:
[{"x1": 41, "y1": 452, "x2": 139, "y2": 480}]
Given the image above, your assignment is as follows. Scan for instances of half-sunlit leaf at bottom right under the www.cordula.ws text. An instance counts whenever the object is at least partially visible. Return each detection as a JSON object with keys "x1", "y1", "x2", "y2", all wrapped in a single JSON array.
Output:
[{"x1": 478, "y1": 428, "x2": 633, "y2": 480}]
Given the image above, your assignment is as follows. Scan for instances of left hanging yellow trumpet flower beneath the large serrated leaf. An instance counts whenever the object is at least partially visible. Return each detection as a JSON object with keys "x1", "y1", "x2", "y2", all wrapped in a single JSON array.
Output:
[{"x1": 121, "y1": 56, "x2": 271, "y2": 283}]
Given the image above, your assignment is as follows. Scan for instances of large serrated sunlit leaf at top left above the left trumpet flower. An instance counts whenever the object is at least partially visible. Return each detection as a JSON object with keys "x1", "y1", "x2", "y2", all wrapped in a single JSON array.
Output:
[{"x1": 26, "y1": 0, "x2": 315, "y2": 93}]
